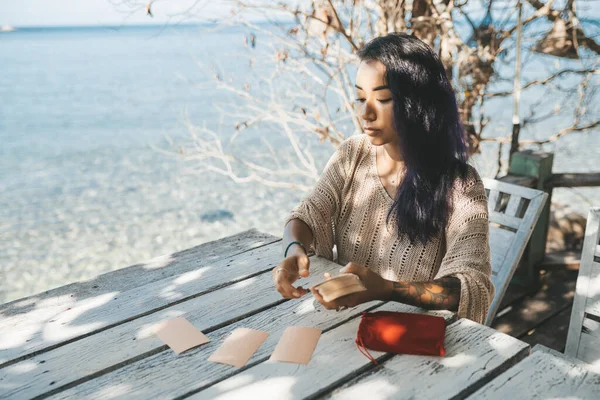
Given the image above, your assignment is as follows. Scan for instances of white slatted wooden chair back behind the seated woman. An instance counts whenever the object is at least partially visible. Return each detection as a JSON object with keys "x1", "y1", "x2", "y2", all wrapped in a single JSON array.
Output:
[{"x1": 483, "y1": 179, "x2": 548, "y2": 326}]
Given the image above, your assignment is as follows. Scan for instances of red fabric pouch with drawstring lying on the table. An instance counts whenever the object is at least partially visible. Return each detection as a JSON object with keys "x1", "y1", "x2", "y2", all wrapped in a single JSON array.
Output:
[{"x1": 356, "y1": 311, "x2": 446, "y2": 364}]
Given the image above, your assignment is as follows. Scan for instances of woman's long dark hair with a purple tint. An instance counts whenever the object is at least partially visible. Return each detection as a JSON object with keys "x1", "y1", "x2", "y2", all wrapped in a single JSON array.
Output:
[{"x1": 358, "y1": 33, "x2": 468, "y2": 244}]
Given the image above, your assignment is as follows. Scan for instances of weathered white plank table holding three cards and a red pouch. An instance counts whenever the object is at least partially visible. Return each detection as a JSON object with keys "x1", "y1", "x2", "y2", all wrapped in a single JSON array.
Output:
[{"x1": 0, "y1": 230, "x2": 544, "y2": 399}]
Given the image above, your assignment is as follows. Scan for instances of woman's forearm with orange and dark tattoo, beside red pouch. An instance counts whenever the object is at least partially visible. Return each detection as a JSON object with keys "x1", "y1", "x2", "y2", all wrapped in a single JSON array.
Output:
[{"x1": 391, "y1": 276, "x2": 460, "y2": 311}]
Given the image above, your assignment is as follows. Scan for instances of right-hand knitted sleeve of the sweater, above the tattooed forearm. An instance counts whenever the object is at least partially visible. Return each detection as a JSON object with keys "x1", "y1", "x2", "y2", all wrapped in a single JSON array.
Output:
[{"x1": 435, "y1": 167, "x2": 494, "y2": 323}]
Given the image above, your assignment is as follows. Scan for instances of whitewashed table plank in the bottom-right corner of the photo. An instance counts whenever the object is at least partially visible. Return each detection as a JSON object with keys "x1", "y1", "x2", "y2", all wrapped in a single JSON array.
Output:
[{"x1": 471, "y1": 345, "x2": 600, "y2": 400}]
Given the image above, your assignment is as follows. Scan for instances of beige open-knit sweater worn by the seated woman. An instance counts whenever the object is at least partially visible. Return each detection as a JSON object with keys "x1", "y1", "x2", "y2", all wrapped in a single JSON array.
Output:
[{"x1": 286, "y1": 135, "x2": 494, "y2": 323}]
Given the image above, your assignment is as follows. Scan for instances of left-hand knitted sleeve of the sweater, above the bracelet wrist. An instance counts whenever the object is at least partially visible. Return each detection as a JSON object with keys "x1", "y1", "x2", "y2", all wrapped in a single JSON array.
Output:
[{"x1": 284, "y1": 138, "x2": 352, "y2": 260}]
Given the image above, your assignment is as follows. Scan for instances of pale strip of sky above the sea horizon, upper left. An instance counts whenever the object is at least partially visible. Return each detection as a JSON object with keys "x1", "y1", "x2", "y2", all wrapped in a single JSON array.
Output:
[{"x1": 0, "y1": 0, "x2": 229, "y2": 27}]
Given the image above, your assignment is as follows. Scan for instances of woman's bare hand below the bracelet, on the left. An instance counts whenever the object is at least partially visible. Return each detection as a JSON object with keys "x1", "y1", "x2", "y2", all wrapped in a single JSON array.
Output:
[{"x1": 273, "y1": 249, "x2": 310, "y2": 299}]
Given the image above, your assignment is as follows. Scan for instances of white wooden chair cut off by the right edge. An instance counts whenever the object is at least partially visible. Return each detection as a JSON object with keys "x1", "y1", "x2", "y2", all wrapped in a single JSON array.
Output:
[{"x1": 565, "y1": 208, "x2": 600, "y2": 365}]
